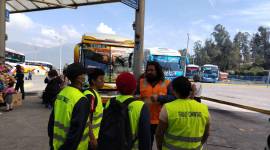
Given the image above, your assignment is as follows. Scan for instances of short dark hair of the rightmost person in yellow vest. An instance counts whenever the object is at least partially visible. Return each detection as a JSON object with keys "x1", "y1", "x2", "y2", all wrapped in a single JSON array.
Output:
[{"x1": 172, "y1": 76, "x2": 192, "y2": 98}]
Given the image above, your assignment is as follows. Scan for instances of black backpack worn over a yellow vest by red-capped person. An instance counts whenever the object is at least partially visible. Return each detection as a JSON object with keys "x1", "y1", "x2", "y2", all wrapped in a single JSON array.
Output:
[{"x1": 98, "y1": 97, "x2": 136, "y2": 150}]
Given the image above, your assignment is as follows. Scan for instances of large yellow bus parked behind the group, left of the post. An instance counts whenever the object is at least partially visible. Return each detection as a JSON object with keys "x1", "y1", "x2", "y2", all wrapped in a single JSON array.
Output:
[{"x1": 74, "y1": 34, "x2": 134, "y2": 82}]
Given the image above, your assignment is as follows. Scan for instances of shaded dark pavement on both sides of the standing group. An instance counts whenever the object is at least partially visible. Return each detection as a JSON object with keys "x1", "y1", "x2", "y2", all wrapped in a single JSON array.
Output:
[{"x1": 0, "y1": 96, "x2": 270, "y2": 150}]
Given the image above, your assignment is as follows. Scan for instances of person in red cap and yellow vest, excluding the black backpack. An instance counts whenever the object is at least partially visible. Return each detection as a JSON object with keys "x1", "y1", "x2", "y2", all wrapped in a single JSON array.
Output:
[{"x1": 102, "y1": 72, "x2": 152, "y2": 150}]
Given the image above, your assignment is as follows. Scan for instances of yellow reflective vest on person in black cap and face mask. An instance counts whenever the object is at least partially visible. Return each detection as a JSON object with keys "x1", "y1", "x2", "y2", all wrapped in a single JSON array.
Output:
[{"x1": 53, "y1": 86, "x2": 89, "y2": 150}]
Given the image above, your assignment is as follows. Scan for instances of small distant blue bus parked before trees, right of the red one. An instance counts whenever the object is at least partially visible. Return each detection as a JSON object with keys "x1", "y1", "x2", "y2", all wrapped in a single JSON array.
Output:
[{"x1": 201, "y1": 64, "x2": 219, "y2": 83}]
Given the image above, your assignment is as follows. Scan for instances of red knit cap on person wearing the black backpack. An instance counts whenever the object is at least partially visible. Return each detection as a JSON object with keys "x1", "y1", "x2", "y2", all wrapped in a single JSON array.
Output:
[{"x1": 116, "y1": 72, "x2": 136, "y2": 95}]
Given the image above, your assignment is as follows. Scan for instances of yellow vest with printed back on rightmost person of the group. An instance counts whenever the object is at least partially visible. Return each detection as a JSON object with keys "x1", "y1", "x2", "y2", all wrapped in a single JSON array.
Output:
[{"x1": 163, "y1": 99, "x2": 209, "y2": 150}]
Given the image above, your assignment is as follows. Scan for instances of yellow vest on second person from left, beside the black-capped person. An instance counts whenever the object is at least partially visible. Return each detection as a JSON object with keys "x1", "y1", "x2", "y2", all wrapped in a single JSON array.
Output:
[{"x1": 83, "y1": 89, "x2": 103, "y2": 139}]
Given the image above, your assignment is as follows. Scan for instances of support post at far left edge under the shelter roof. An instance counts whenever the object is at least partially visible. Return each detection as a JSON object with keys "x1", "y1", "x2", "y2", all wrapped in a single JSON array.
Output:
[{"x1": 0, "y1": 0, "x2": 6, "y2": 64}]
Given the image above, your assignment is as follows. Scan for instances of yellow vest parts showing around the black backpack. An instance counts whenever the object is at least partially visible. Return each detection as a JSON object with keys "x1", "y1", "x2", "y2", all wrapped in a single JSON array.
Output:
[{"x1": 105, "y1": 95, "x2": 144, "y2": 150}]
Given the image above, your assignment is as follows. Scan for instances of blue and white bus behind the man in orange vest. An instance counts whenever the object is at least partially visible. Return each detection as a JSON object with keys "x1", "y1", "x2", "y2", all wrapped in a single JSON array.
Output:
[{"x1": 144, "y1": 48, "x2": 184, "y2": 80}]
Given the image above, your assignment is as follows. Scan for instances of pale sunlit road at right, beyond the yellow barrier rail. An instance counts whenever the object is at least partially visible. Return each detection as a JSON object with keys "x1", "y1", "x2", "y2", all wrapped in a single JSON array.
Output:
[{"x1": 202, "y1": 83, "x2": 270, "y2": 110}]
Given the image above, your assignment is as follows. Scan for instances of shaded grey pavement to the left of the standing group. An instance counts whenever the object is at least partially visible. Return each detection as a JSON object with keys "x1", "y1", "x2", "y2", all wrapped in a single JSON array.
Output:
[{"x1": 0, "y1": 95, "x2": 50, "y2": 150}]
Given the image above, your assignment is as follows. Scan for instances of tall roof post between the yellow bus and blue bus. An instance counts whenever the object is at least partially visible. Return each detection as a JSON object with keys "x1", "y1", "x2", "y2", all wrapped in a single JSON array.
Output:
[{"x1": 133, "y1": 0, "x2": 145, "y2": 79}]
